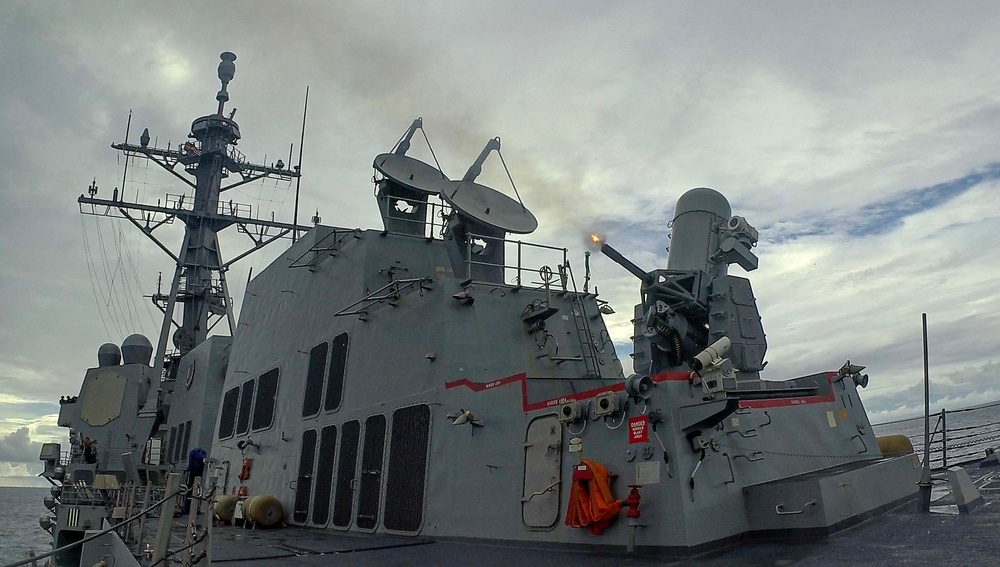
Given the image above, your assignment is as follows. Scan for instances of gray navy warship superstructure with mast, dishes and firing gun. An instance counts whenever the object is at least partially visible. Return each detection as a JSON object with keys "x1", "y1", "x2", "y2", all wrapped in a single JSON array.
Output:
[{"x1": 29, "y1": 52, "x2": 984, "y2": 565}]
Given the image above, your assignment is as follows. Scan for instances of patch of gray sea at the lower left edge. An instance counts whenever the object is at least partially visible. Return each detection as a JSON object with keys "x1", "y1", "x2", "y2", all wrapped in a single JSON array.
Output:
[{"x1": 0, "y1": 486, "x2": 51, "y2": 565}]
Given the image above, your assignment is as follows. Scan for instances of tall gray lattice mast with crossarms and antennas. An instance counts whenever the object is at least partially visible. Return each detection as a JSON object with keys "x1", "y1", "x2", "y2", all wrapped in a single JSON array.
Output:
[{"x1": 78, "y1": 52, "x2": 308, "y2": 369}]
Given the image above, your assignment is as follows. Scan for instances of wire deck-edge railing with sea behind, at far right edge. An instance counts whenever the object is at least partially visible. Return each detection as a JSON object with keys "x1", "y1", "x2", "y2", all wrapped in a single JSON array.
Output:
[{"x1": 877, "y1": 402, "x2": 1000, "y2": 470}]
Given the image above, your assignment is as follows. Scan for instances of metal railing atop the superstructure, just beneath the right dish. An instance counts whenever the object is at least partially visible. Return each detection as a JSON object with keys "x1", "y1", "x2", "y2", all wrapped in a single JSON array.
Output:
[{"x1": 465, "y1": 233, "x2": 570, "y2": 292}]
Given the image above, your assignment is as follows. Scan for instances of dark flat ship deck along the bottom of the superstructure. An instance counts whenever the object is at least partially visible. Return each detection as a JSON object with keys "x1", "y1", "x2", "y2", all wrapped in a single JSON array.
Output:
[{"x1": 195, "y1": 468, "x2": 1000, "y2": 567}]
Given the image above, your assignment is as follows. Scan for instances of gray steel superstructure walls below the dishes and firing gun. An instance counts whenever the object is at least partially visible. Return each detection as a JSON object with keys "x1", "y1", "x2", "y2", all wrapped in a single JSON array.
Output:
[{"x1": 212, "y1": 221, "x2": 916, "y2": 548}]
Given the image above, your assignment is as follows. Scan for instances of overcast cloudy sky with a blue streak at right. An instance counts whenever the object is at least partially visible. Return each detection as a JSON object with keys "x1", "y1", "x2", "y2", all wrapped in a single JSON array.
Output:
[{"x1": 0, "y1": 1, "x2": 1000, "y2": 484}]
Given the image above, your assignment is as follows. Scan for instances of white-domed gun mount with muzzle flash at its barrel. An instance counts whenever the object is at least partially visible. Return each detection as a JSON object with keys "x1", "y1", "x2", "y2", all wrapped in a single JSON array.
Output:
[{"x1": 601, "y1": 187, "x2": 767, "y2": 380}]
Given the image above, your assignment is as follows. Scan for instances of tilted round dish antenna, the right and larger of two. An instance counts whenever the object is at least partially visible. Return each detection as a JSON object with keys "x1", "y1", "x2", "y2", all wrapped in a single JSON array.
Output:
[{"x1": 441, "y1": 181, "x2": 538, "y2": 234}]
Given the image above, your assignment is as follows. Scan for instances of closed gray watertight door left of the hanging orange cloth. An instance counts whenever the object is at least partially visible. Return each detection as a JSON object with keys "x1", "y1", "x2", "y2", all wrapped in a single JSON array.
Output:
[{"x1": 521, "y1": 415, "x2": 562, "y2": 528}]
